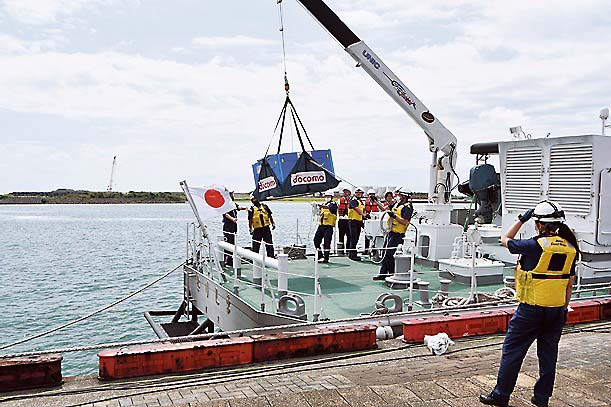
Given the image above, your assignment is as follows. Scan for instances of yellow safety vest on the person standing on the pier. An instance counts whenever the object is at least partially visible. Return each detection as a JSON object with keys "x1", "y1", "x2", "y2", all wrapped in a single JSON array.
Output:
[{"x1": 516, "y1": 236, "x2": 577, "y2": 307}]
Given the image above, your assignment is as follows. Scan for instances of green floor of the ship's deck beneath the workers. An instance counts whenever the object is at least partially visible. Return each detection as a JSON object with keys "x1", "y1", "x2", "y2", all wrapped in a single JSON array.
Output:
[{"x1": 223, "y1": 256, "x2": 513, "y2": 321}]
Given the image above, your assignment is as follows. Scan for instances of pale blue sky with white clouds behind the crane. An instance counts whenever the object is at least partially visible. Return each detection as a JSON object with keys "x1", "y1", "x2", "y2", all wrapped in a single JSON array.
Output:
[{"x1": 0, "y1": 0, "x2": 611, "y2": 193}]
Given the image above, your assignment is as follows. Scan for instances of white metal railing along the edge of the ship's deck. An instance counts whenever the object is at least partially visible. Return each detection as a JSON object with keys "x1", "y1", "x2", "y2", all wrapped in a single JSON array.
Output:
[{"x1": 187, "y1": 226, "x2": 611, "y2": 321}]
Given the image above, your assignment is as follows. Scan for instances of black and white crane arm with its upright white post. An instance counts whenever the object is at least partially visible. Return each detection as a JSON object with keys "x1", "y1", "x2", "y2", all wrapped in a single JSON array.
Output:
[{"x1": 296, "y1": 0, "x2": 457, "y2": 204}]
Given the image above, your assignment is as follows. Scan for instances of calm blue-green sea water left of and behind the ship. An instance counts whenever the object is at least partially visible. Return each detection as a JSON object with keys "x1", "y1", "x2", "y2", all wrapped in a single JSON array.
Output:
[{"x1": 0, "y1": 203, "x2": 316, "y2": 376}]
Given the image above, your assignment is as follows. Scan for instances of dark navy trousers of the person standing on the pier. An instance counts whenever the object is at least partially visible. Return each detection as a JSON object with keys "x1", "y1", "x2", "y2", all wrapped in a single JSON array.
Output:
[{"x1": 493, "y1": 304, "x2": 566, "y2": 403}]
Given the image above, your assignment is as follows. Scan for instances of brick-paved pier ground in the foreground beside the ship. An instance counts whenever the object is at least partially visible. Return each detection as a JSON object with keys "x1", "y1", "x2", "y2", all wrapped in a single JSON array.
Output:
[{"x1": 0, "y1": 322, "x2": 611, "y2": 407}]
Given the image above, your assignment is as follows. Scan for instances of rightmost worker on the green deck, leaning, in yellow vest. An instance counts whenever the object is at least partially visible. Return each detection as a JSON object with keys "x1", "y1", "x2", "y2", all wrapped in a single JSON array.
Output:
[{"x1": 373, "y1": 188, "x2": 414, "y2": 280}]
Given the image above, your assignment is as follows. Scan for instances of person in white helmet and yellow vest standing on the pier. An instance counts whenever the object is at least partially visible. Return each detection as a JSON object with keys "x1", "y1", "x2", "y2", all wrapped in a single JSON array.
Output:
[{"x1": 479, "y1": 201, "x2": 579, "y2": 406}]
